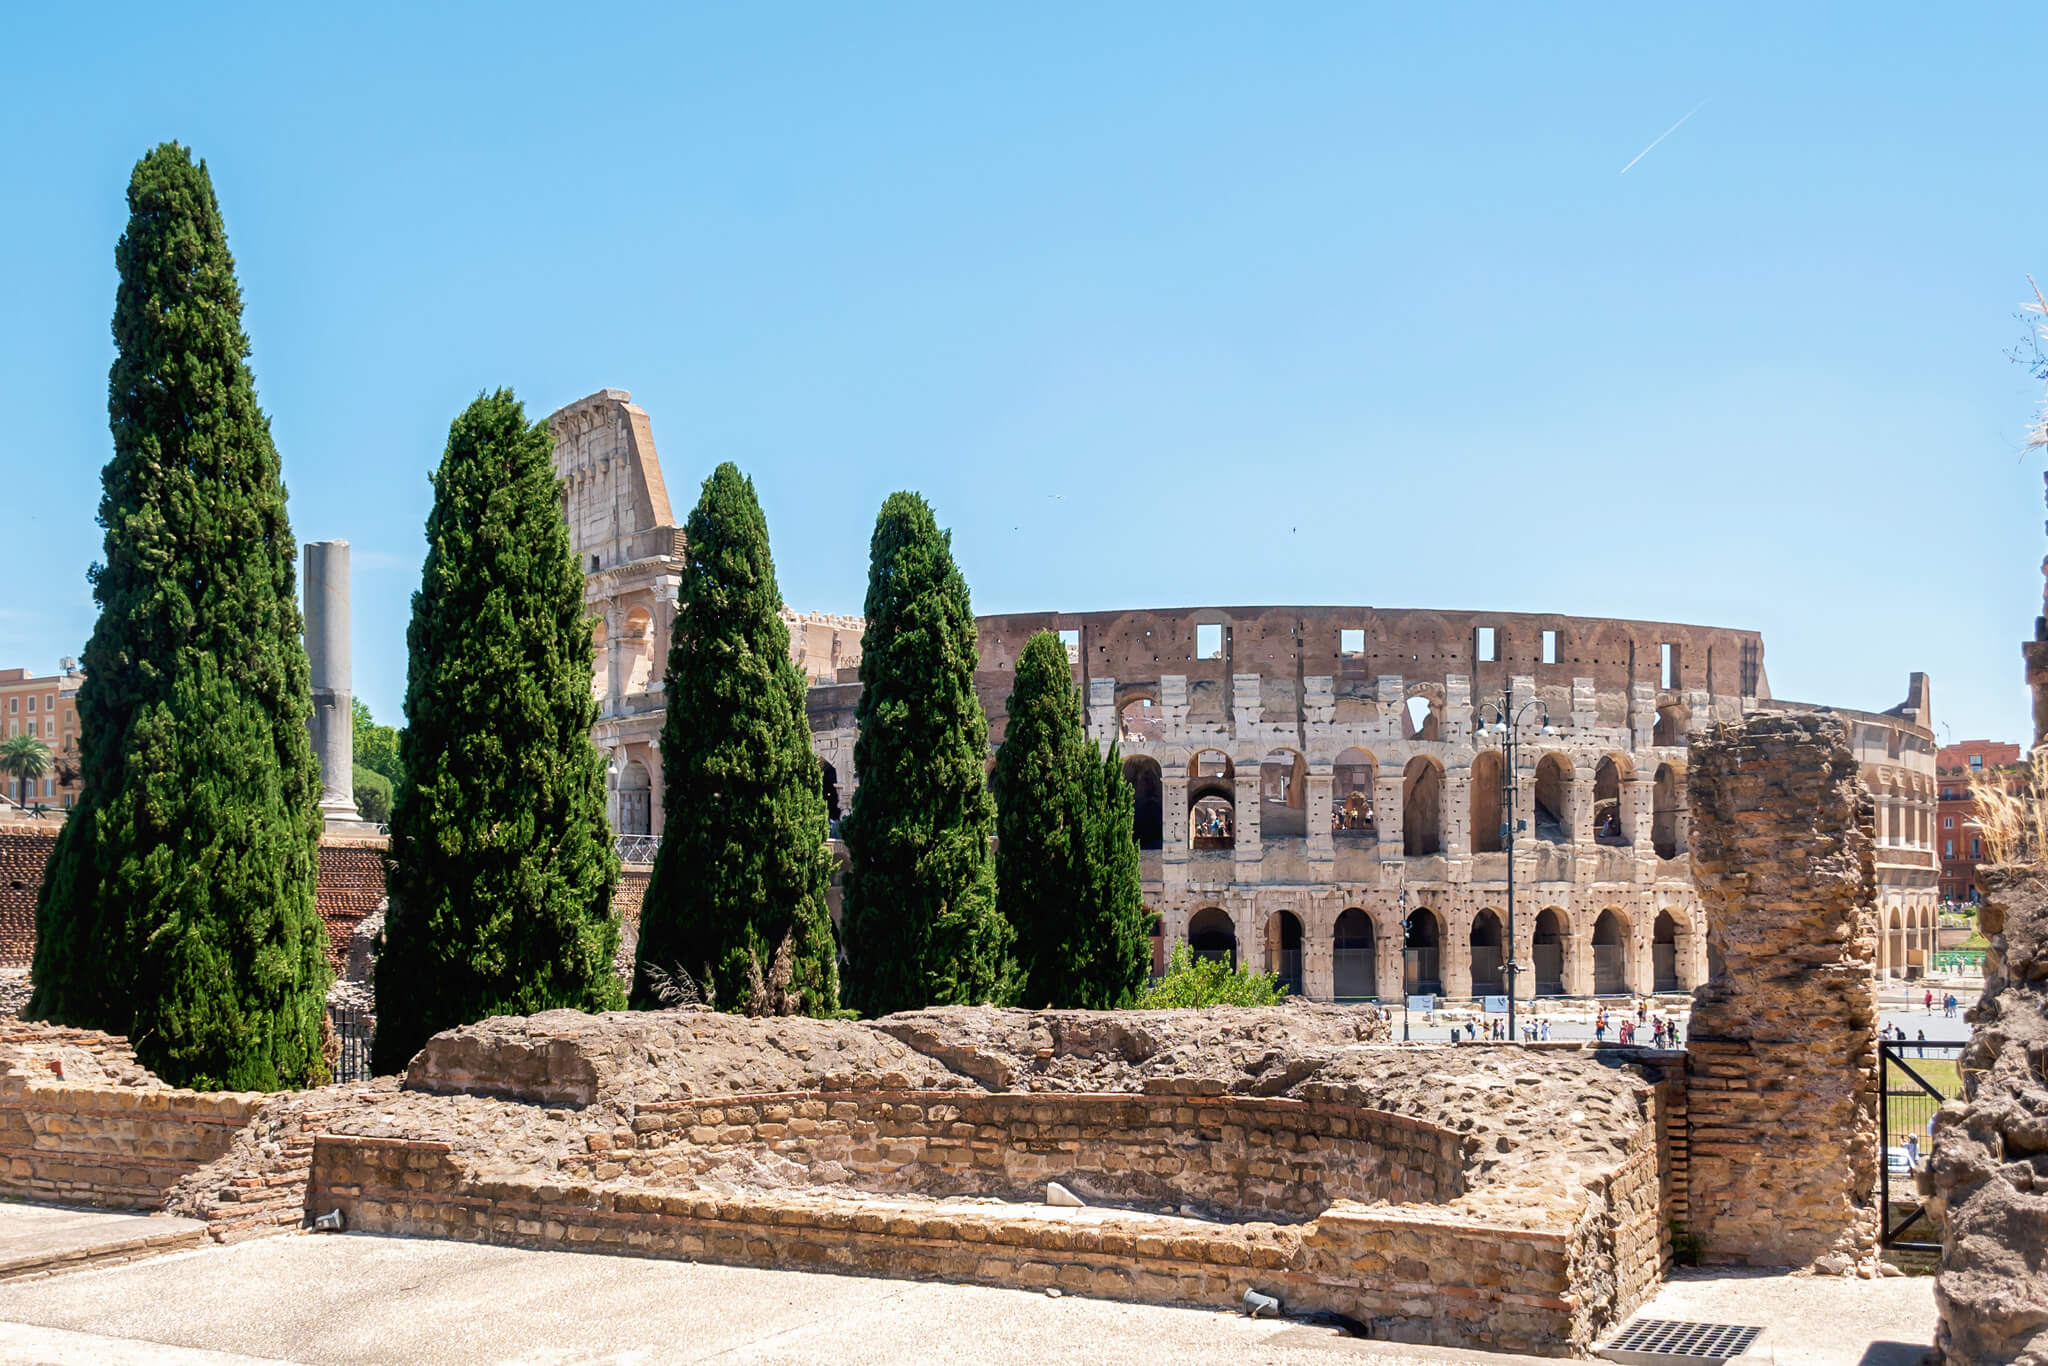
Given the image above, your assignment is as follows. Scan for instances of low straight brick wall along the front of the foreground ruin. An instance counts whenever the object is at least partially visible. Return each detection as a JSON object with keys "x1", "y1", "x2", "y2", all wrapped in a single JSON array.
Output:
[{"x1": 307, "y1": 1122, "x2": 1605, "y2": 1356}]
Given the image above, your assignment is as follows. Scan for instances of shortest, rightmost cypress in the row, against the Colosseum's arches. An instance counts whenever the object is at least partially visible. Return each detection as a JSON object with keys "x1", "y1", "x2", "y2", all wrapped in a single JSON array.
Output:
[{"x1": 993, "y1": 631, "x2": 1151, "y2": 1010}]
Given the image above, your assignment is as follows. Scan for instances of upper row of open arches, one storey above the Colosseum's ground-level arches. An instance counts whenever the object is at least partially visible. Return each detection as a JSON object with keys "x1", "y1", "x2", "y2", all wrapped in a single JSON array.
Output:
[{"x1": 1124, "y1": 750, "x2": 1686, "y2": 858}]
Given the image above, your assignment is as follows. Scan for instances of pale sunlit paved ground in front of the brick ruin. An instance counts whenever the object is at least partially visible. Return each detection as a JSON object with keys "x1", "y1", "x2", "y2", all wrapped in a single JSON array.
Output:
[{"x1": 0, "y1": 1206, "x2": 1933, "y2": 1366}]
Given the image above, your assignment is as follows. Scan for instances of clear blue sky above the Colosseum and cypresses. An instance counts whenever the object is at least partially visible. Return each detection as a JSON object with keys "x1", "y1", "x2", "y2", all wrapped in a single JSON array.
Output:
[{"x1": 0, "y1": 4, "x2": 2048, "y2": 739}]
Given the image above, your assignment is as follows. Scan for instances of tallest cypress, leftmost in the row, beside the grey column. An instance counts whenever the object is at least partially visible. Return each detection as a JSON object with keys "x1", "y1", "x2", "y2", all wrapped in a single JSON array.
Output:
[{"x1": 29, "y1": 143, "x2": 330, "y2": 1090}]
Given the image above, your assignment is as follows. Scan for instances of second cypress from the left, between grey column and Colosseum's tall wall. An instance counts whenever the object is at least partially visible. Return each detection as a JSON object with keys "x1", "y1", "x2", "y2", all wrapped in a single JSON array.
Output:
[{"x1": 371, "y1": 389, "x2": 625, "y2": 1073}]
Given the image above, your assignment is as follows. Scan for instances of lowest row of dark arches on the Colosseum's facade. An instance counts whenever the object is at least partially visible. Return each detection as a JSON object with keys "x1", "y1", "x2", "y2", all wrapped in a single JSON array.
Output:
[{"x1": 1188, "y1": 905, "x2": 1698, "y2": 1001}]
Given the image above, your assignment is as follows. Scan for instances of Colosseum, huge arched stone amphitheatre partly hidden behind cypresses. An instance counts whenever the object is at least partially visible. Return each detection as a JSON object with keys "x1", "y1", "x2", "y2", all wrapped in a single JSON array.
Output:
[{"x1": 553, "y1": 389, "x2": 1937, "y2": 1001}]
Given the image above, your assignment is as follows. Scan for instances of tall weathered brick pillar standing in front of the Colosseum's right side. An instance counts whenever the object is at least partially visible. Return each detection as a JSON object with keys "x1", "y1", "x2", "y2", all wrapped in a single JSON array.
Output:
[{"x1": 1686, "y1": 713, "x2": 1878, "y2": 1272}]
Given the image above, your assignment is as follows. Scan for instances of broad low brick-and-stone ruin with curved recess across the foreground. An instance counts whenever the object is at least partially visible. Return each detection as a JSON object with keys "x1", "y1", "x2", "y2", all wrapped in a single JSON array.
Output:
[{"x1": 0, "y1": 1006, "x2": 1669, "y2": 1354}]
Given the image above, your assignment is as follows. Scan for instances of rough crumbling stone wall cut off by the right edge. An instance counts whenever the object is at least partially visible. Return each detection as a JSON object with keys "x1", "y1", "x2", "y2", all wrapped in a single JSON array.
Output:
[{"x1": 1929, "y1": 866, "x2": 2048, "y2": 1366}]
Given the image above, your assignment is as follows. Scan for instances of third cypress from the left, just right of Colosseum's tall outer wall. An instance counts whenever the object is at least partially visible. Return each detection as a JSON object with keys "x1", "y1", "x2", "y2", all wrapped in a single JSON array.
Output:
[{"x1": 633, "y1": 463, "x2": 840, "y2": 1016}]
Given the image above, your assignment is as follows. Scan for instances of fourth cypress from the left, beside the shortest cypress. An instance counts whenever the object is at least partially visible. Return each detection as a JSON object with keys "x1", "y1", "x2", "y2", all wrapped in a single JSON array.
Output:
[{"x1": 840, "y1": 494, "x2": 1016, "y2": 1016}]
